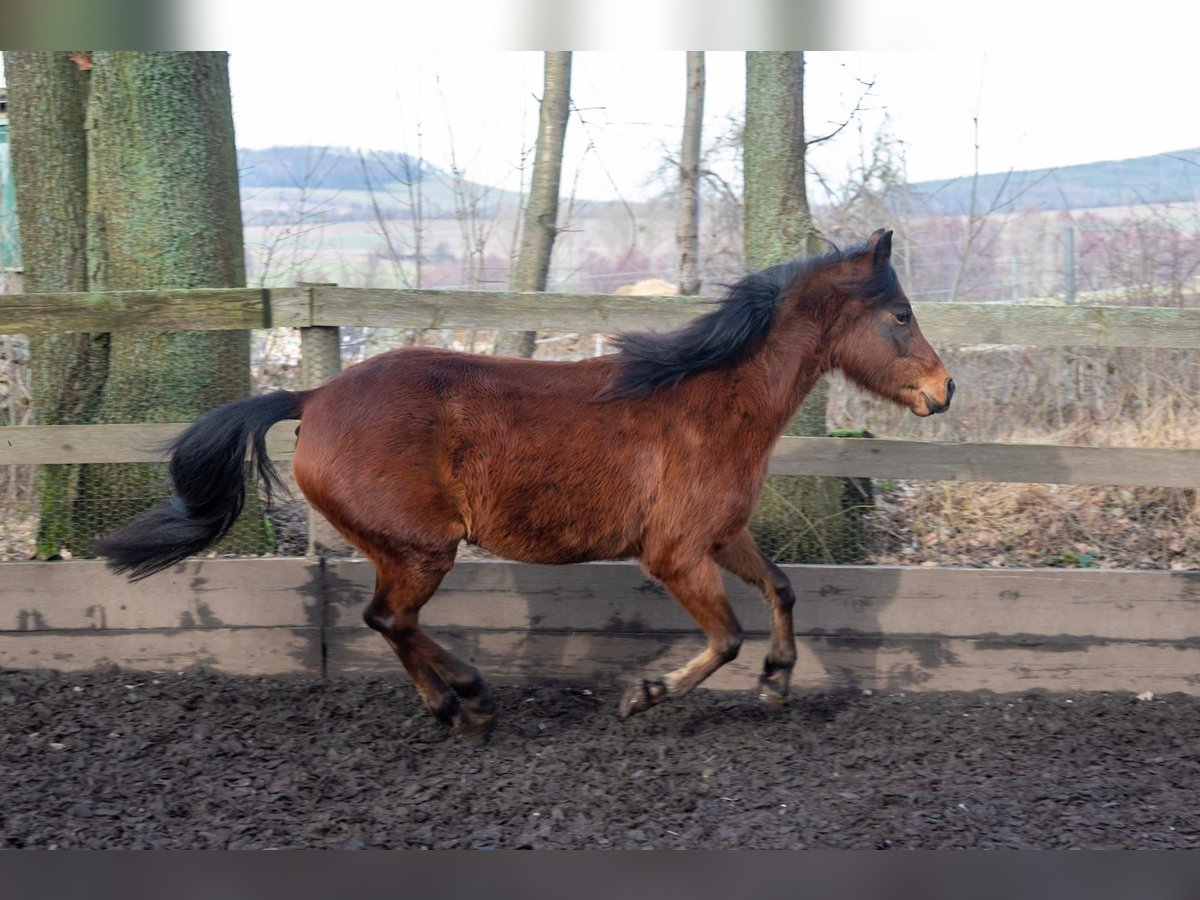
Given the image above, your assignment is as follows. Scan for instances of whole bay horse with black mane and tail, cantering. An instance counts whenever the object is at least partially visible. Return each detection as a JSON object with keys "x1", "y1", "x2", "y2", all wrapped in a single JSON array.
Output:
[{"x1": 94, "y1": 229, "x2": 954, "y2": 737}]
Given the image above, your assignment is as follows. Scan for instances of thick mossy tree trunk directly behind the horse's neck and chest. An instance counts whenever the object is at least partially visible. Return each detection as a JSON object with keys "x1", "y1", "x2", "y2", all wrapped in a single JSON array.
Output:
[{"x1": 743, "y1": 50, "x2": 852, "y2": 563}]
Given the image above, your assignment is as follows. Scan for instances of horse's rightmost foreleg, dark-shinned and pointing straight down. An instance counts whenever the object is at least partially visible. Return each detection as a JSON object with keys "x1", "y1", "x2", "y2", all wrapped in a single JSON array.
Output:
[{"x1": 715, "y1": 528, "x2": 796, "y2": 706}]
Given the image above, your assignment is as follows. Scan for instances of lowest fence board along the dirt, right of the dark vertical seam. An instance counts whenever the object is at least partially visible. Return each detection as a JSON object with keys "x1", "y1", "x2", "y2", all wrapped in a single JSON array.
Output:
[{"x1": 326, "y1": 629, "x2": 1200, "y2": 708}]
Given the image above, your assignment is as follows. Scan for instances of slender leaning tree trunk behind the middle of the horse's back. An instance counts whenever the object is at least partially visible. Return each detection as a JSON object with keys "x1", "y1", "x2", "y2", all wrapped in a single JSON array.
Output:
[{"x1": 494, "y1": 52, "x2": 571, "y2": 356}]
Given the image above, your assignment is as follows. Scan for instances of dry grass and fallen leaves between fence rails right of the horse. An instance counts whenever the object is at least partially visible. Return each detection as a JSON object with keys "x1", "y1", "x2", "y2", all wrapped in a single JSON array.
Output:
[{"x1": 829, "y1": 347, "x2": 1200, "y2": 569}]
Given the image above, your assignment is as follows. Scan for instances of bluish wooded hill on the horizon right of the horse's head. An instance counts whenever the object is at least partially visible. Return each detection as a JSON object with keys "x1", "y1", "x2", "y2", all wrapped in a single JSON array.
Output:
[{"x1": 908, "y1": 148, "x2": 1200, "y2": 216}]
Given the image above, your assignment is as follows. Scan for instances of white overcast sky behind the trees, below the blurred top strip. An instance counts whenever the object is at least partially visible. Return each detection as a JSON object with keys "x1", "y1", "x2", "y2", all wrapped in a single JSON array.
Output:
[{"x1": 216, "y1": 48, "x2": 1200, "y2": 199}]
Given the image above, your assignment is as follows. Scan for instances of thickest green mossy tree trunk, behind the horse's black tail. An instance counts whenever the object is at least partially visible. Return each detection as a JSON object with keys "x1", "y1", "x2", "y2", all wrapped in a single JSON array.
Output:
[{"x1": 72, "y1": 50, "x2": 272, "y2": 553}]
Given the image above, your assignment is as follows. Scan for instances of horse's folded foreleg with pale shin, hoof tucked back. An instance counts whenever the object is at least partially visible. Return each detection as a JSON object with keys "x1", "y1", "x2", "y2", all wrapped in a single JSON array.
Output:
[{"x1": 620, "y1": 557, "x2": 742, "y2": 718}]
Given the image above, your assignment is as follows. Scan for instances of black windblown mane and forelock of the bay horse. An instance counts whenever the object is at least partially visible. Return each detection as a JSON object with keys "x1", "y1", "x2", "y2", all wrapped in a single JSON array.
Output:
[{"x1": 601, "y1": 237, "x2": 900, "y2": 400}]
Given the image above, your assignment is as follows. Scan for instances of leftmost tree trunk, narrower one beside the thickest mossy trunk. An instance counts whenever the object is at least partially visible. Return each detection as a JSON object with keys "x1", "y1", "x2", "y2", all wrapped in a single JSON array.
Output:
[{"x1": 5, "y1": 50, "x2": 109, "y2": 559}]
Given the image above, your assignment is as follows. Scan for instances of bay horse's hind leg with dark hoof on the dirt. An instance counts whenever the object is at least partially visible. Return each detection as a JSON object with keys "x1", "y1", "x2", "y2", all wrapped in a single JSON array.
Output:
[{"x1": 362, "y1": 547, "x2": 496, "y2": 738}]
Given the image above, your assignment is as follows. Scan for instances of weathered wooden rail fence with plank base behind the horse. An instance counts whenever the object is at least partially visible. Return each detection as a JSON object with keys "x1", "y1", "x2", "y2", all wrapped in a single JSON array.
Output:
[{"x1": 7, "y1": 286, "x2": 1200, "y2": 692}]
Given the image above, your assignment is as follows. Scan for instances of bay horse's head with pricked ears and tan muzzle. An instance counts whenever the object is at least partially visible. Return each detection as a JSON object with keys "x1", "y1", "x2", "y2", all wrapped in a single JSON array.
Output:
[{"x1": 829, "y1": 228, "x2": 954, "y2": 416}]
